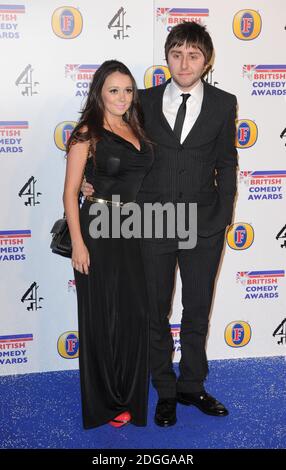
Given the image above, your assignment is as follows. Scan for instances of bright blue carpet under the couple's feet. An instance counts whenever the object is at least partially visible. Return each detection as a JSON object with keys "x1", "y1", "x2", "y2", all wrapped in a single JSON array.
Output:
[{"x1": 0, "y1": 357, "x2": 286, "y2": 449}]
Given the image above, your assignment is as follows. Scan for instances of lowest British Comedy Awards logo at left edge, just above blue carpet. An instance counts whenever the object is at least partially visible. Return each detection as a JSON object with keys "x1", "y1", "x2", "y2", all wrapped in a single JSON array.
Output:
[{"x1": 0, "y1": 334, "x2": 33, "y2": 366}]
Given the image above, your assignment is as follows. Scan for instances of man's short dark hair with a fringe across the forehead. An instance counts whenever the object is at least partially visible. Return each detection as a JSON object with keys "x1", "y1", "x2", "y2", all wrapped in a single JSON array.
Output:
[{"x1": 165, "y1": 21, "x2": 214, "y2": 64}]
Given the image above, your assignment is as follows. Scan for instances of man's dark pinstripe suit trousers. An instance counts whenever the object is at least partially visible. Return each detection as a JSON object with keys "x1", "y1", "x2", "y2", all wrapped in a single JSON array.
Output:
[{"x1": 142, "y1": 230, "x2": 225, "y2": 398}]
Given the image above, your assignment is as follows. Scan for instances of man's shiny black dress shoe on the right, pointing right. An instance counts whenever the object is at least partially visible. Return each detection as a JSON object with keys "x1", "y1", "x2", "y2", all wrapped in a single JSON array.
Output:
[{"x1": 177, "y1": 392, "x2": 228, "y2": 416}]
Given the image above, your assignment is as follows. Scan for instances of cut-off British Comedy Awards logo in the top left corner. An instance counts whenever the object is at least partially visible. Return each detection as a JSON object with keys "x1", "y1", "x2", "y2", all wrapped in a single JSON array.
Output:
[{"x1": 0, "y1": 5, "x2": 26, "y2": 40}]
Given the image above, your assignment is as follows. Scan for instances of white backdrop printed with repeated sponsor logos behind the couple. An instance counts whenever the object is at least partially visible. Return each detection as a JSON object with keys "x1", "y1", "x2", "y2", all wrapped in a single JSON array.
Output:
[{"x1": 0, "y1": 0, "x2": 286, "y2": 375}]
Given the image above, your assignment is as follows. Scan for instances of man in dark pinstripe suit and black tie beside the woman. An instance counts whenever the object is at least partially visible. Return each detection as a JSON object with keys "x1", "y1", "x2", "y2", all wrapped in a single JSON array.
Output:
[{"x1": 83, "y1": 22, "x2": 237, "y2": 427}]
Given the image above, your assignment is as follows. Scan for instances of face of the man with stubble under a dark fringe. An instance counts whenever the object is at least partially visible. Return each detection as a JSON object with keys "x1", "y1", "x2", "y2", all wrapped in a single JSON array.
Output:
[{"x1": 165, "y1": 43, "x2": 208, "y2": 92}]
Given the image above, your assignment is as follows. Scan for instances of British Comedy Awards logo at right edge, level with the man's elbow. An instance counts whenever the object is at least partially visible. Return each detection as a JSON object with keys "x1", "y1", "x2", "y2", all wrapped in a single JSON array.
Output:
[{"x1": 239, "y1": 170, "x2": 286, "y2": 201}]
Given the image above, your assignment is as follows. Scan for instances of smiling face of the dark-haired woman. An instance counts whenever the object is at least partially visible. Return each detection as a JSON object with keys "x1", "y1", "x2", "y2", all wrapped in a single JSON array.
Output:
[{"x1": 101, "y1": 72, "x2": 133, "y2": 120}]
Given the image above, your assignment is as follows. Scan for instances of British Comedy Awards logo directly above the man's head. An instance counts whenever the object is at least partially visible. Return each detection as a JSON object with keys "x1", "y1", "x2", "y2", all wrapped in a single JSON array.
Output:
[{"x1": 156, "y1": 7, "x2": 209, "y2": 32}]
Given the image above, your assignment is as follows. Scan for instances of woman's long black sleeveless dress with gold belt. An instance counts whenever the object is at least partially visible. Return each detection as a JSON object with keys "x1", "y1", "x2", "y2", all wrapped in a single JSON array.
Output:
[{"x1": 74, "y1": 130, "x2": 152, "y2": 428}]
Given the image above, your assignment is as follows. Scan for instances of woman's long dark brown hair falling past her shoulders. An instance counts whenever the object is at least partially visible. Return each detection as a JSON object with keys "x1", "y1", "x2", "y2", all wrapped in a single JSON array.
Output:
[{"x1": 66, "y1": 60, "x2": 151, "y2": 155}]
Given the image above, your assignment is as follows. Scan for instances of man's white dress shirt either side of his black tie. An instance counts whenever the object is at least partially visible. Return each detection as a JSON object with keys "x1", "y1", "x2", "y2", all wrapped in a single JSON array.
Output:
[{"x1": 163, "y1": 79, "x2": 204, "y2": 143}]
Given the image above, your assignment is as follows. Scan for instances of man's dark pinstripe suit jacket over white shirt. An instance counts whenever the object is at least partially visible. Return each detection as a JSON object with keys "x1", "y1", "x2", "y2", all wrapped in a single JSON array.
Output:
[{"x1": 137, "y1": 81, "x2": 237, "y2": 237}]
